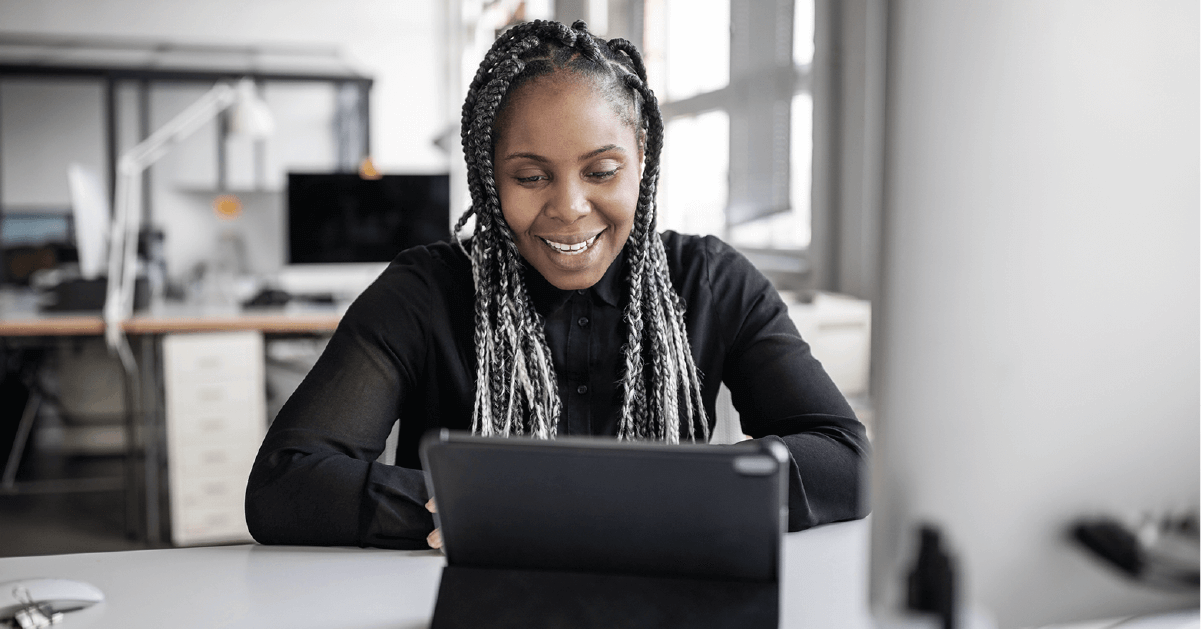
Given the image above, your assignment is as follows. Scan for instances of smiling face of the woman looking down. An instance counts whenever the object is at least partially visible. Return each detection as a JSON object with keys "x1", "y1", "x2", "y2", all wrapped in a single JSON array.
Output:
[{"x1": 494, "y1": 76, "x2": 643, "y2": 290}]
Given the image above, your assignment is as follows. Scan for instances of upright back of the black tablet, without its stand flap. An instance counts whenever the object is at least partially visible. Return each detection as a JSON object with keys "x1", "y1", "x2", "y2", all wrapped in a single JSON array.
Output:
[{"x1": 422, "y1": 430, "x2": 788, "y2": 582}]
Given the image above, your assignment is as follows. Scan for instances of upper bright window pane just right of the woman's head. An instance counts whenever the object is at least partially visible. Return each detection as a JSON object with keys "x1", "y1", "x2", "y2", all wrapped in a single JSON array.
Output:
[{"x1": 663, "y1": 0, "x2": 730, "y2": 101}]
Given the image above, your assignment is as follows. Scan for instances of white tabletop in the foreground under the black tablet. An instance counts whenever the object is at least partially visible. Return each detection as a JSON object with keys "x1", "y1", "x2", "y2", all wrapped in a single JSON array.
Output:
[{"x1": 0, "y1": 521, "x2": 872, "y2": 629}]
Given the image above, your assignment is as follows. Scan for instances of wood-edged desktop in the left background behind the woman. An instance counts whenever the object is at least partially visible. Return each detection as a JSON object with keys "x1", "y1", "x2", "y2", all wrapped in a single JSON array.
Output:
[{"x1": 0, "y1": 290, "x2": 345, "y2": 336}]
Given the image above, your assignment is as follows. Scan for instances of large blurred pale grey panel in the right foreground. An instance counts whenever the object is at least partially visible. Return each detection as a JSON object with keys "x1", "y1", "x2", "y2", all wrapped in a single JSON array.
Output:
[{"x1": 871, "y1": 0, "x2": 1201, "y2": 629}]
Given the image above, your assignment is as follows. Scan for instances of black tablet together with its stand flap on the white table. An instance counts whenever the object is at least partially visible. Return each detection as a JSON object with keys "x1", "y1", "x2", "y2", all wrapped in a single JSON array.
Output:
[{"x1": 422, "y1": 431, "x2": 788, "y2": 629}]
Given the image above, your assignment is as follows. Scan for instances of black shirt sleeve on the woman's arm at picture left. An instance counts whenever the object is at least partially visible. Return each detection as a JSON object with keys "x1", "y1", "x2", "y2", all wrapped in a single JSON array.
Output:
[{"x1": 246, "y1": 243, "x2": 470, "y2": 549}]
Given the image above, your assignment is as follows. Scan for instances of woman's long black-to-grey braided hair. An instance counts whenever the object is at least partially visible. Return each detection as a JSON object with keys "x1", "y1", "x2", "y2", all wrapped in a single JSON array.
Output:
[{"x1": 454, "y1": 20, "x2": 709, "y2": 443}]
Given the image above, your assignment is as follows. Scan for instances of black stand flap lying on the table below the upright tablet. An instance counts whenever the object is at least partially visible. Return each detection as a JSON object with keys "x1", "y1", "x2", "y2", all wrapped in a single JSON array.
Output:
[{"x1": 430, "y1": 565, "x2": 779, "y2": 629}]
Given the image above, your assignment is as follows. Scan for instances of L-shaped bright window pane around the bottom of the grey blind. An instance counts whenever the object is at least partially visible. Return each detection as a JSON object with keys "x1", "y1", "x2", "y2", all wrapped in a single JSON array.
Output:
[{"x1": 730, "y1": 94, "x2": 813, "y2": 250}]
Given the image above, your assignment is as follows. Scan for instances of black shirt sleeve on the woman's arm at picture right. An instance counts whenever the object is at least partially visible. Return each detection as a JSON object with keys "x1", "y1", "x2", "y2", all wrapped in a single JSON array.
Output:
[{"x1": 673, "y1": 232, "x2": 868, "y2": 531}]
